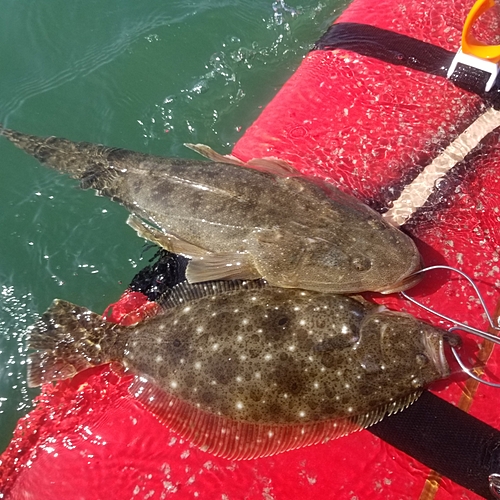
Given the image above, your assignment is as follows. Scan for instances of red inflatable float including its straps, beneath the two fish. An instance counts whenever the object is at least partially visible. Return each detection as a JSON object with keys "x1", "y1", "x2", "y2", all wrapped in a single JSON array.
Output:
[{"x1": 0, "y1": 0, "x2": 500, "y2": 500}]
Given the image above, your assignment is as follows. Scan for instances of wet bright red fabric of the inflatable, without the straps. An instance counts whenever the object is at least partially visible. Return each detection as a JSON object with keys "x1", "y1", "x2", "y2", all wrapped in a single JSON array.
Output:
[{"x1": 0, "y1": 0, "x2": 500, "y2": 500}]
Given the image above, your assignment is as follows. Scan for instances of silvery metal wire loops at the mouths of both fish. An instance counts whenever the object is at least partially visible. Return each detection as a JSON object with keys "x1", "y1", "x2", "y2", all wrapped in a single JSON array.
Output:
[{"x1": 400, "y1": 265, "x2": 500, "y2": 388}]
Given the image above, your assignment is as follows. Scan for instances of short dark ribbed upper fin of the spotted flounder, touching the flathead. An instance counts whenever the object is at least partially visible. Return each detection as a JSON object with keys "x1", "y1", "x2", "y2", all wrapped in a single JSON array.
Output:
[{"x1": 158, "y1": 280, "x2": 268, "y2": 309}]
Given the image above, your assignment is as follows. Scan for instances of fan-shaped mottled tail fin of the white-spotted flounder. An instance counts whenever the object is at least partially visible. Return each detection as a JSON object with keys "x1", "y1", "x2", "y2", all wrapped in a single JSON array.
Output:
[{"x1": 28, "y1": 300, "x2": 123, "y2": 387}]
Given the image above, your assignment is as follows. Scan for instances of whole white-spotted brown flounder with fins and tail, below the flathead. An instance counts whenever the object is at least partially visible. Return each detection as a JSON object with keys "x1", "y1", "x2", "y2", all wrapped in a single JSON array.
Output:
[{"x1": 28, "y1": 281, "x2": 456, "y2": 459}]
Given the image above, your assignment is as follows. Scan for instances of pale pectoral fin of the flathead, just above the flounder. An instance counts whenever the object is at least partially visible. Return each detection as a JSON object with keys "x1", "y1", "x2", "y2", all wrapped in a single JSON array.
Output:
[{"x1": 186, "y1": 252, "x2": 262, "y2": 283}]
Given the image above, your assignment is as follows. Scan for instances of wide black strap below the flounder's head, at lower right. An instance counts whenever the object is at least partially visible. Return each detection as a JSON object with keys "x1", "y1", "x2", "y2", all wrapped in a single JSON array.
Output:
[{"x1": 368, "y1": 391, "x2": 500, "y2": 500}]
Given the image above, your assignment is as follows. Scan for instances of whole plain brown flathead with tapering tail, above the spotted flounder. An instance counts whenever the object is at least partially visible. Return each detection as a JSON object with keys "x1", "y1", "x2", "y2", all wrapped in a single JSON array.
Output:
[{"x1": 0, "y1": 127, "x2": 420, "y2": 293}]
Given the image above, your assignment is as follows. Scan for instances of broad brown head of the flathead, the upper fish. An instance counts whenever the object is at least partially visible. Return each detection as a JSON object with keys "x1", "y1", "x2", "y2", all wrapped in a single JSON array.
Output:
[{"x1": 288, "y1": 179, "x2": 422, "y2": 294}]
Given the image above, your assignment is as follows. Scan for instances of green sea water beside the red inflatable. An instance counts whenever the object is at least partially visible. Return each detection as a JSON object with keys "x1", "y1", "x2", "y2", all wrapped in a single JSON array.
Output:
[{"x1": 0, "y1": 0, "x2": 348, "y2": 451}]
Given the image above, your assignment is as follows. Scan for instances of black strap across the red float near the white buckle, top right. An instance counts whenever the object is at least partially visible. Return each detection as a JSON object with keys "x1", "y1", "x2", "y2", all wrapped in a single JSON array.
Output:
[{"x1": 313, "y1": 23, "x2": 500, "y2": 109}]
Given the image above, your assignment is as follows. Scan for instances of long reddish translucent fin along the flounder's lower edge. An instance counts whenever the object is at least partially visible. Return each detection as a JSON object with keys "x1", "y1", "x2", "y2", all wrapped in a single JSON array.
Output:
[{"x1": 129, "y1": 375, "x2": 420, "y2": 460}]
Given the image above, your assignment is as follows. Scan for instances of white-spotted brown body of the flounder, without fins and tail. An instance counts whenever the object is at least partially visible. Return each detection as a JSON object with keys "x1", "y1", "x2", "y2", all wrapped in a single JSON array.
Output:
[{"x1": 123, "y1": 288, "x2": 450, "y2": 423}]
